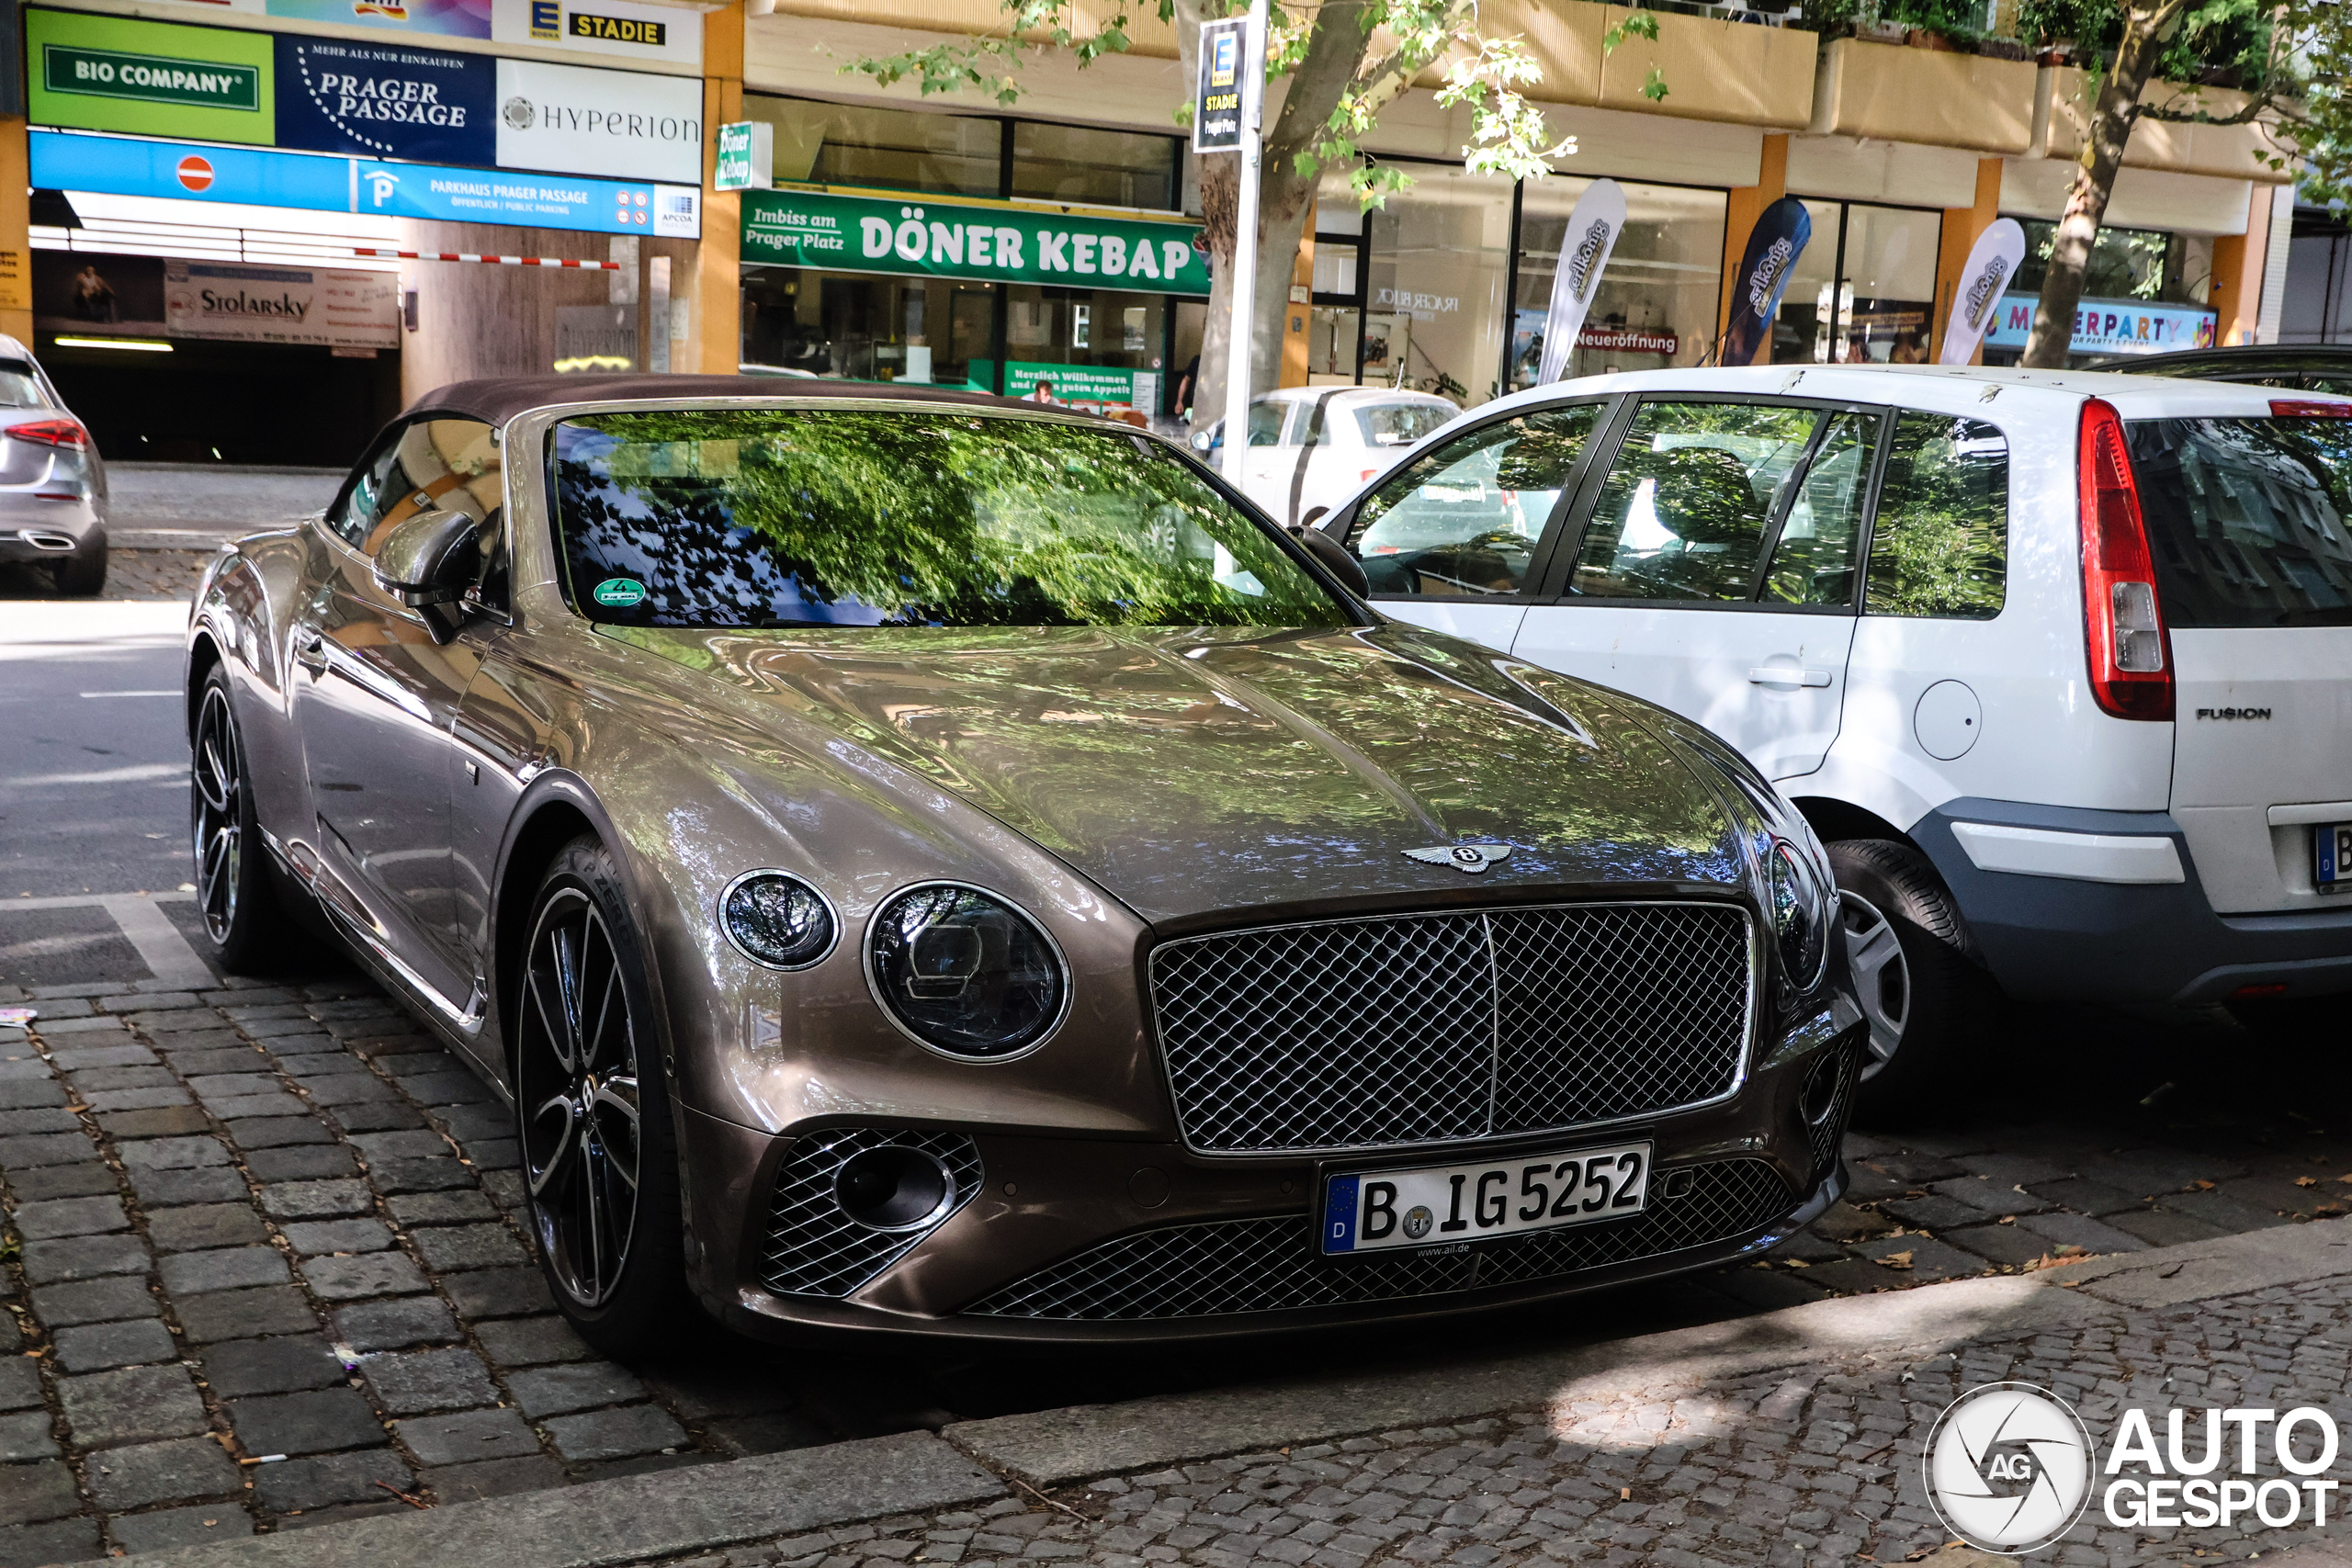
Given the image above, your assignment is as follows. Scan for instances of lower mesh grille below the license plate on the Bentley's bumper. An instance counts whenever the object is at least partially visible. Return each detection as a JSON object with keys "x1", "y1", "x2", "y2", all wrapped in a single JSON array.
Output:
[{"x1": 965, "y1": 1159, "x2": 1797, "y2": 1324}]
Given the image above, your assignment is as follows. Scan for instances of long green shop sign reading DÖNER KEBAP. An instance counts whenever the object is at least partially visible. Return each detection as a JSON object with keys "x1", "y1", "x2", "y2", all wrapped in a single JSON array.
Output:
[{"x1": 743, "y1": 190, "x2": 1209, "y2": 296}]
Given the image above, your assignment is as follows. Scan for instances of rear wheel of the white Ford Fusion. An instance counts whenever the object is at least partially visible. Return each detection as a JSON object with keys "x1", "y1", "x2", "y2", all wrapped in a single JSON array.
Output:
[{"x1": 1827, "y1": 840, "x2": 1996, "y2": 1126}]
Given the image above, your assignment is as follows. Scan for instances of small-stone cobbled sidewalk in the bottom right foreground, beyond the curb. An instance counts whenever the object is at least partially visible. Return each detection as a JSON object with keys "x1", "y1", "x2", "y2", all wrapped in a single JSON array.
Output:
[{"x1": 635, "y1": 1279, "x2": 2352, "y2": 1568}]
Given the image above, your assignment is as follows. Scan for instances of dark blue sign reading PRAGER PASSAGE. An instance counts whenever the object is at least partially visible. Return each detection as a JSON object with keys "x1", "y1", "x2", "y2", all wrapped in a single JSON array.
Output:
[{"x1": 277, "y1": 33, "x2": 499, "y2": 164}]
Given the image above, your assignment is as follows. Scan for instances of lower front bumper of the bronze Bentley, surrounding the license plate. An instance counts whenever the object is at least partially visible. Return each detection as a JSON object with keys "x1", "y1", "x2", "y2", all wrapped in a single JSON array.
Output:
[{"x1": 682, "y1": 1027, "x2": 1860, "y2": 1345}]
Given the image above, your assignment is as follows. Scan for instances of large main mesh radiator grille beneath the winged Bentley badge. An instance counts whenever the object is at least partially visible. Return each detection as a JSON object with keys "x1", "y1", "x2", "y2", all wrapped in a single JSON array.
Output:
[{"x1": 1150, "y1": 903, "x2": 1750, "y2": 1155}]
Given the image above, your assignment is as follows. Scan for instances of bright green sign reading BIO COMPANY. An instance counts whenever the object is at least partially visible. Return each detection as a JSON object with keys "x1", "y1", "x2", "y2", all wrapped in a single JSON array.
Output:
[{"x1": 24, "y1": 9, "x2": 277, "y2": 146}]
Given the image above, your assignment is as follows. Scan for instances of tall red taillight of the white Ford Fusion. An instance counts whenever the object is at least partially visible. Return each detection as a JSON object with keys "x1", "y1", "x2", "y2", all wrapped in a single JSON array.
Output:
[{"x1": 2082, "y1": 398, "x2": 2173, "y2": 719}]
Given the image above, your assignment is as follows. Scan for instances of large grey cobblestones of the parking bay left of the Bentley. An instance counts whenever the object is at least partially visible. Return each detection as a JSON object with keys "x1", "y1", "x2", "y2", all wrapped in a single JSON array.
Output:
[{"x1": 0, "y1": 980, "x2": 983, "y2": 1565}]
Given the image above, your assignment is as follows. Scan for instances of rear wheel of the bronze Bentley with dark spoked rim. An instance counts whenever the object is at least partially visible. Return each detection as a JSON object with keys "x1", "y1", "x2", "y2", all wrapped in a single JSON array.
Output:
[{"x1": 188, "y1": 665, "x2": 306, "y2": 976}]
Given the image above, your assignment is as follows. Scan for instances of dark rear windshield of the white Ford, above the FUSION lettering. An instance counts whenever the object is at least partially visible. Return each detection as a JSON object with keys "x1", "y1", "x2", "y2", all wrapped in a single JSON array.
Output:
[{"x1": 2129, "y1": 419, "x2": 2352, "y2": 627}]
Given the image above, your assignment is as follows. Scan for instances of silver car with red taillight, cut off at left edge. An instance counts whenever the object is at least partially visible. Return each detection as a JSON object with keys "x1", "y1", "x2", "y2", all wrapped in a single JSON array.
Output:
[{"x1": 0, "y1": 336, "x2": 106, "y2": 597}]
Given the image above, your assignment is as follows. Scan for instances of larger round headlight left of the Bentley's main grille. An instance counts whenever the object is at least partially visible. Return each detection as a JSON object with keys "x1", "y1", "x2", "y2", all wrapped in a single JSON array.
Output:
[{"x1": 865, "y1": 882, "x2": 1070, "y2": 1060}]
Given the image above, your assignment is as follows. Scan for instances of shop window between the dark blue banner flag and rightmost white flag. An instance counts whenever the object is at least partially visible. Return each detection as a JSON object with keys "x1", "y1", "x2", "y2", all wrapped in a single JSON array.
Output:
[{"x1": 1771, "y1": 202, "x2": 1943, "y2": 365}]
